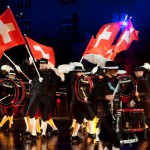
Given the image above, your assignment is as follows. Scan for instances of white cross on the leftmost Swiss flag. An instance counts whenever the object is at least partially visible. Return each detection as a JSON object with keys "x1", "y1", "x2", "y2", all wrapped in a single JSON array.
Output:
[{"x1": 0, "y1": 20, "x2": 15, "y2": 44}]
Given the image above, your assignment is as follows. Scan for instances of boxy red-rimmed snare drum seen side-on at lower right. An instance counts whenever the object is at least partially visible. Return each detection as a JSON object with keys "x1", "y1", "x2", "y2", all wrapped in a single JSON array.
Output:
[{"x1": 116, "y1": 109, "x2": 145, "y2": 133}]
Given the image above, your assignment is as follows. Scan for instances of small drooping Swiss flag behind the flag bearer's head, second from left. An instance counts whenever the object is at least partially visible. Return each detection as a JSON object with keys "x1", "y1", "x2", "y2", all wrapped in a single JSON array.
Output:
[{"x1": 25, "y1": 36, "x2": 55, "y2": 66}]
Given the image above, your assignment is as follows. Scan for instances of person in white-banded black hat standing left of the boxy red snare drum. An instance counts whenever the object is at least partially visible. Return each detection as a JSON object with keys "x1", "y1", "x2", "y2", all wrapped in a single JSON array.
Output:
[{"x1": 99, "y1": 61, "x2": 120, "y2": 150}]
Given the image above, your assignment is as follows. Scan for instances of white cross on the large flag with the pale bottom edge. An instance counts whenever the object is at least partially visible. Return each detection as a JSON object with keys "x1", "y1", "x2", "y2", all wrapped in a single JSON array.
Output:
[{"x1": 94, "y1": 25, "x2": 112, "y2": 47}]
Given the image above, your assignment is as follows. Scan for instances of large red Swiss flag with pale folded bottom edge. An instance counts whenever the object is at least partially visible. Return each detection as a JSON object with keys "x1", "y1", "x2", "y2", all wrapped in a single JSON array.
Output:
[{"x1": 83, "y1": 21, "x2": 123, "y2": 66}]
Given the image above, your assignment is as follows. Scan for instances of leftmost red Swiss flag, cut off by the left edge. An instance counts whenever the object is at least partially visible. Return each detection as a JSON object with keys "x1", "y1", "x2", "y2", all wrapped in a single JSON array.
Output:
[{"x1": 0, "y1": 8, "x2": 25, "y2": 56}]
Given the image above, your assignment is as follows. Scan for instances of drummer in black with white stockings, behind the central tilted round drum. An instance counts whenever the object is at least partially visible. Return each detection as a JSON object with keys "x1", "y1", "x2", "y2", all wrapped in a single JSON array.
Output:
[{"x1": 70, "y1": 66, "x2": 96, "y2": 144}]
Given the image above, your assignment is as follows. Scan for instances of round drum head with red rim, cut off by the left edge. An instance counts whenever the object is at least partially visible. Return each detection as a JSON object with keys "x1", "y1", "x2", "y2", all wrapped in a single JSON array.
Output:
[{"x1": 0, "y1": 79, "x2": 19, "y2": 107}]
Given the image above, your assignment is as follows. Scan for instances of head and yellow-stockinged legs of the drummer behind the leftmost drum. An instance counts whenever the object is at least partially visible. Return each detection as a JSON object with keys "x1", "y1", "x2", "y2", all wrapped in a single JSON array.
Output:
[{"x1": 0, "y1": 70, "x2": 16, "y2": 130}]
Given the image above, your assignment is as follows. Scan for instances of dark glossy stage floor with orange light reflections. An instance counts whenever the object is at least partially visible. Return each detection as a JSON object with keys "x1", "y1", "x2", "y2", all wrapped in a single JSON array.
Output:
[{"x1": 0, "y1": 117, "x2": 150, "y2": 150}]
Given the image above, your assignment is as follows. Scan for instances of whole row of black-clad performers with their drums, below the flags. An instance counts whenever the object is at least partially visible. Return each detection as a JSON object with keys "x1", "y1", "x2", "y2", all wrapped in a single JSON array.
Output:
[{"x1": 0, "y1": 58, "x2": 150, "y2": 150}]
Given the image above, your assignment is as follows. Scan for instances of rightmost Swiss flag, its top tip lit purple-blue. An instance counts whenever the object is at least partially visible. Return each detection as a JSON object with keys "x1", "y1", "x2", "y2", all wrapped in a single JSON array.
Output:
[{"x1": 114, "y1": 19, "x2": 139, "y2": 53}]
